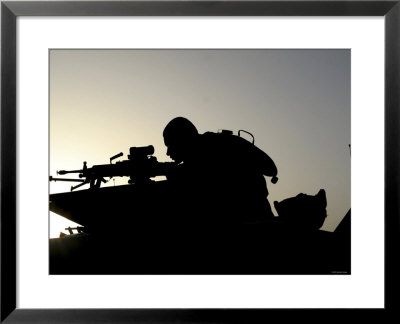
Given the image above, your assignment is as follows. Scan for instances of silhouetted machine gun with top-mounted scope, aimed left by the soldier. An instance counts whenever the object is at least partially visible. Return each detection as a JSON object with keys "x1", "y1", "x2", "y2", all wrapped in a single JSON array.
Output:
[{"x1": 50, "y1": 145, "x2": 176, "y2": 191}]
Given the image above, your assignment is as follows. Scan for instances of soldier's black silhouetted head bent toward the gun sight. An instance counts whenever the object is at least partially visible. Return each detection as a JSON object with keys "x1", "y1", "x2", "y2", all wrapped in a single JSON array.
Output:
[{"x1": 163, "y1": 117, "x2": 199, "y2": 163}]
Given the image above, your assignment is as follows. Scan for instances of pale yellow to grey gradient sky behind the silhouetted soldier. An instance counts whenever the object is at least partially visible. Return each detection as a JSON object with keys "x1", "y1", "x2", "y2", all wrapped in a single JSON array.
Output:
[{"x1": 49, "y1": 49, "x2": 351, "y2": 237}]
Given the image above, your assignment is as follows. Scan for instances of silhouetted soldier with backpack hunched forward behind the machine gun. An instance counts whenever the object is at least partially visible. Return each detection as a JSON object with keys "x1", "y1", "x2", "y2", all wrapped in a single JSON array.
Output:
[{"x1": 163, "y1": 117, "x2": 278, "y2": 222}]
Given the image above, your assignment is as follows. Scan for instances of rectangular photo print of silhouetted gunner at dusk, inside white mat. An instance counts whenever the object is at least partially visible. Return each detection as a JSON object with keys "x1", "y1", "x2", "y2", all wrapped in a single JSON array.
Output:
[{"x1": 49, "y1": 49, "x2": 351, "y2": 275}]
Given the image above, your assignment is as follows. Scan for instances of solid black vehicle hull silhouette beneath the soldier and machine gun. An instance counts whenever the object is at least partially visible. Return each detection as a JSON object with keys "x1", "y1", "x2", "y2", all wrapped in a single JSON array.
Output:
[{"x1": 50, "y1": 181, "x2": 351, "y2": 274}]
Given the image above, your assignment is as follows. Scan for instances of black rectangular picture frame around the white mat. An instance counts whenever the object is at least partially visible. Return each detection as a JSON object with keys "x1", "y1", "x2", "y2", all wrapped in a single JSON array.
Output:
[{"x1": 0, "y1": 0, "x2": 400, "y2": 323}]
